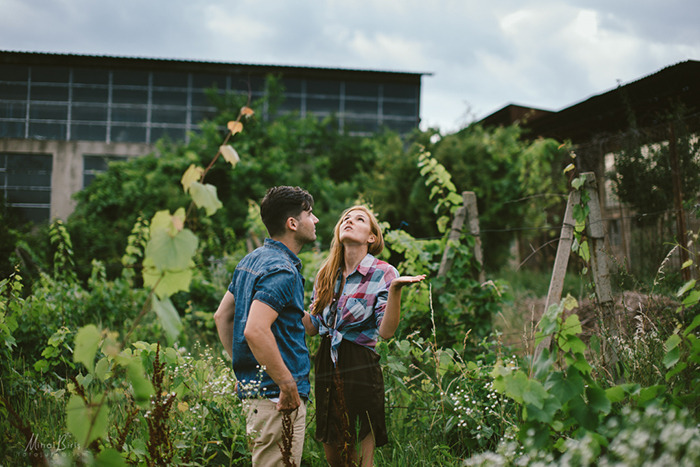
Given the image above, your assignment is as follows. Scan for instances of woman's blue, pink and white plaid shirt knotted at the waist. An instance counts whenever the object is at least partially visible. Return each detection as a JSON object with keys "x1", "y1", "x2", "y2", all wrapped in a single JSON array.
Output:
[{"x1": 311, "y1": 253, "x2": 399, "y2": 363}]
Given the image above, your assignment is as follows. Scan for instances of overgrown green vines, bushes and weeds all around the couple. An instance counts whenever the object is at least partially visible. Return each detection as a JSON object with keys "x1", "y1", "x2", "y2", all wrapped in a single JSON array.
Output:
[{"x1": 0, "y1": 89, "x2": 700, "y2": 466}]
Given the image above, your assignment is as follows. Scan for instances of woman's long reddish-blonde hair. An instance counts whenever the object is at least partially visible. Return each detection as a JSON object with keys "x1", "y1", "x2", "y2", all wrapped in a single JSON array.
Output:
[{"x1": 310, "y1": 205, "x2": 384, "y2": 315}]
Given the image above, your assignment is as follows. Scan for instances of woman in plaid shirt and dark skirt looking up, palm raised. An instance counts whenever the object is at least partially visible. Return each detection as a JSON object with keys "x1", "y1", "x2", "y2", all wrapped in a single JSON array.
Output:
[{"x1": 304, "y1": 206, "x2": 425, "y2": 466}]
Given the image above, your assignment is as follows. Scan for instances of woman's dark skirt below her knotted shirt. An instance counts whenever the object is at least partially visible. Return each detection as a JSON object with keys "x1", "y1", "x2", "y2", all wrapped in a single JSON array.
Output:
[{"x1": 315, "y1": 336, "x2": 388, "y2": 447}]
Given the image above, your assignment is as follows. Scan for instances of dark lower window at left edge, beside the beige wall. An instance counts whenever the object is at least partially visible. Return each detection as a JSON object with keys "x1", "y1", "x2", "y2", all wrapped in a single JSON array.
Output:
[{"x1": 0, "y1": 153, "x2": 53, "y2": 222}]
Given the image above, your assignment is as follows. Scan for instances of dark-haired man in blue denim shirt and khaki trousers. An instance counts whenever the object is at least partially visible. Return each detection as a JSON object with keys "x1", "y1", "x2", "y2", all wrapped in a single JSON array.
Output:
[{"x1": 214, "y1": 186, "x2": 318, "y2": 466}]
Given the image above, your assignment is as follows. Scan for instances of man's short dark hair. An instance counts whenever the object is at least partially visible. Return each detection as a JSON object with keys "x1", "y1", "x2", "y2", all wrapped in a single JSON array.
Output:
[{"x1": 260, "y1": 186, "x2": 314, "y2": 237}]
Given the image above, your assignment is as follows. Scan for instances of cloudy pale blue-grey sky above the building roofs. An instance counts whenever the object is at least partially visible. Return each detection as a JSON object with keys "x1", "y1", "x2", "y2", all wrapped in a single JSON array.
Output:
[{"x1": 0, "y1": 0, "x2": 700, "y2": 134}]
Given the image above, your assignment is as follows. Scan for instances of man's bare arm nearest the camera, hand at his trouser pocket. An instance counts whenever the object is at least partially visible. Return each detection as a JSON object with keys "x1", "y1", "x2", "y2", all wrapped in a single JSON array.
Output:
[{"x1": 243, "y1": 300, "x2": 301, "y2": 411}]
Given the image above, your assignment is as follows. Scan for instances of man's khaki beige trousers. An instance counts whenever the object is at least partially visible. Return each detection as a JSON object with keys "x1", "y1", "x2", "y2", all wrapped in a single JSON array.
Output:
[{"x1": 242, "y1": 399, "x2": 306, "y2": 467}]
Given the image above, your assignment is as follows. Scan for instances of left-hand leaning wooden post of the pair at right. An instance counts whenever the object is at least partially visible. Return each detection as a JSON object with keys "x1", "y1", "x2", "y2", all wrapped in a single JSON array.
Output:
[{"x1": 534, "y1": 190, "x2": 581, "y2": 360}]
